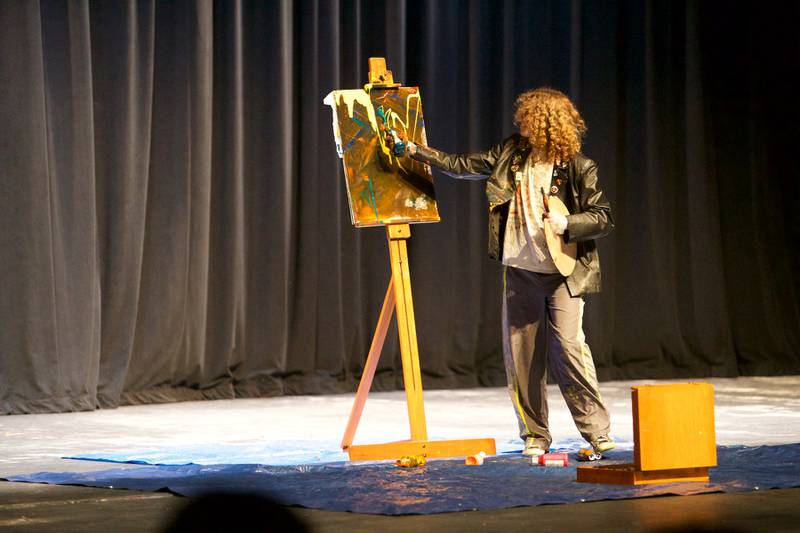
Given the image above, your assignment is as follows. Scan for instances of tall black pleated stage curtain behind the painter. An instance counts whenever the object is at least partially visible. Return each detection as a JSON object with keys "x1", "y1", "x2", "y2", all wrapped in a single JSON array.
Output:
[{"x1": 0, "y1": 0, "x2": 800, "y2": 413}]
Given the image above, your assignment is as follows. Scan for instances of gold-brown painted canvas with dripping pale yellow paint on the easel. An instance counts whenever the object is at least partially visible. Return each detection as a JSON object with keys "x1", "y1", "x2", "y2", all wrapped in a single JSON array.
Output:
[{"x1": 325, "y1": 87, "x2": 439, "y2": 227}]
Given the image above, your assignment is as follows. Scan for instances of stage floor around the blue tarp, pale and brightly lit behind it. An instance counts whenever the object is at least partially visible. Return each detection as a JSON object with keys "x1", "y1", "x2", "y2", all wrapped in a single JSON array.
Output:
[{"x1": 0, "y1": 376, "x2": 800, "y2": 530}]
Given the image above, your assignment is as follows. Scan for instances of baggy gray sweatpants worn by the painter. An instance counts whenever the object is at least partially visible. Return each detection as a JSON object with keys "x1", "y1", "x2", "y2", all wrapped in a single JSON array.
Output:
[{"x1": 503, "y1": 266, "x2": 610, "y2": 449}]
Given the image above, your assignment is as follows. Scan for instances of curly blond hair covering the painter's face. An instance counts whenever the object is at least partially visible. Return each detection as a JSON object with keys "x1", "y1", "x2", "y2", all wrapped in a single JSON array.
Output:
[{"x1": 514, "y1": 87, "x2": 586, "y2": 163}]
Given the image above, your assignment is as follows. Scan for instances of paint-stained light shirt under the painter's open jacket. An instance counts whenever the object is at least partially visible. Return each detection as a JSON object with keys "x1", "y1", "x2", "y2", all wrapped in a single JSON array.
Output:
[{"x1": 503, "y1": 157, "x2": 558, "y2": 274}]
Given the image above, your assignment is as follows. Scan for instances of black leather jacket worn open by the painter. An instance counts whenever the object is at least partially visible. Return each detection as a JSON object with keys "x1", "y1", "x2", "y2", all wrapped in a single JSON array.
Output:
[{"x1": 412, "y1": 133, "x2": 614, "y2": 297}]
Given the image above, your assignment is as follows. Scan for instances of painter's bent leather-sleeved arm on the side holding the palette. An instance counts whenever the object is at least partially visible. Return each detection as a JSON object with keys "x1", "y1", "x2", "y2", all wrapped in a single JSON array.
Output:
[{"x1": 564, "y1": 159, "x2": 614, "y2": 242}]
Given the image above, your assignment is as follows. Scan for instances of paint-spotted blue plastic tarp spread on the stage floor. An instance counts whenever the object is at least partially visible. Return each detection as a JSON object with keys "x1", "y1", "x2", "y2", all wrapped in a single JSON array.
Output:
[{"x1": 8, "y1": 444, "x2": 800, "y2": 515}]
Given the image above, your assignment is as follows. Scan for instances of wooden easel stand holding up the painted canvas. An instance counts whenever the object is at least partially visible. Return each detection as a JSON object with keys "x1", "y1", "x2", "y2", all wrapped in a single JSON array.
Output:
[{"x1": 342, "y1": 57, "x2": 497, "y2": 461}]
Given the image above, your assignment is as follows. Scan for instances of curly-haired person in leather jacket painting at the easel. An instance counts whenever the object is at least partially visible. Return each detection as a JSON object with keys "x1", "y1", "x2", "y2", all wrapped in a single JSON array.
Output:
[{"x1": 400, "y1": 88, "x2": 615, "y2": 455}]
